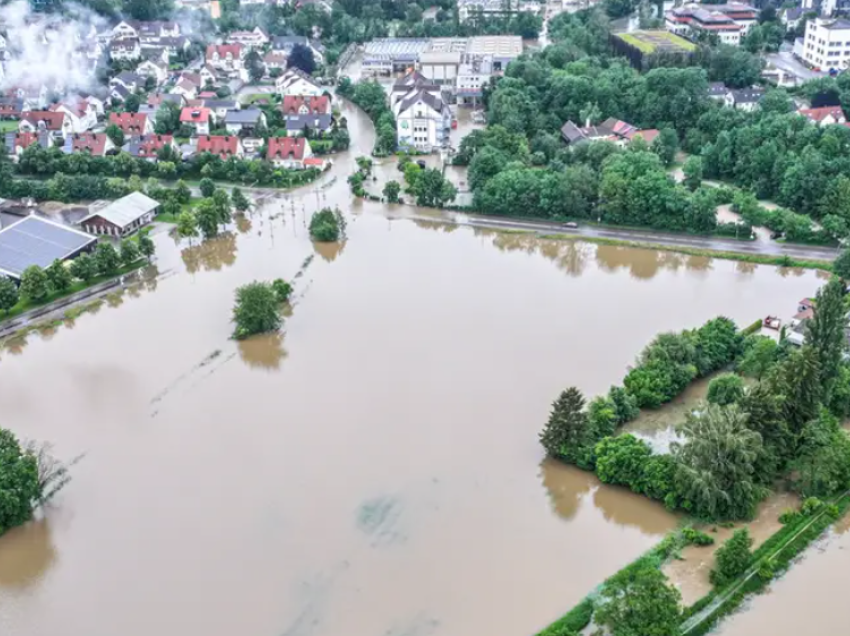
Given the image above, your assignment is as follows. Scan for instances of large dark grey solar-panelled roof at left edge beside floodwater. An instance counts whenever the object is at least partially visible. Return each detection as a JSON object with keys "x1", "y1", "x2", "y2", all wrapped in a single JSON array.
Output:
[{"x1": 0, "y1": 215, "x2": 97, "y2": 278}]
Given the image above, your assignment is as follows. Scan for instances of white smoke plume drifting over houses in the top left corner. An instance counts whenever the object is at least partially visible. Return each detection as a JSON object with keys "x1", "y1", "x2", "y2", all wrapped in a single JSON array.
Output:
[{"x1": 0, "y1": 0, "x2": 109, "y2": 94}]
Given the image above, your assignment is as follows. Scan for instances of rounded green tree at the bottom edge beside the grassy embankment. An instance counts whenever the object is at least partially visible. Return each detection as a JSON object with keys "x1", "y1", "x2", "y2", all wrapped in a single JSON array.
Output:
[{"x1": 593, "y1": 564, "x2": 682, "y2": 636}]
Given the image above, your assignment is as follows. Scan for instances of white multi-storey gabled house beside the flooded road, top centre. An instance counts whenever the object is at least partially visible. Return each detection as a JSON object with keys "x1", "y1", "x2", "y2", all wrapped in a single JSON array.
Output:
[{"x1": 393, "y1": 89, "x2": 452, "y2": 152}]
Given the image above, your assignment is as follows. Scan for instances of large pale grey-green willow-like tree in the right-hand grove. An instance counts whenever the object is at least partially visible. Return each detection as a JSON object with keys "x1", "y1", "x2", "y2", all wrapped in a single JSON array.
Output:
[{"x1": 671, "y1": 404, "x2": 765, "y2": 519}]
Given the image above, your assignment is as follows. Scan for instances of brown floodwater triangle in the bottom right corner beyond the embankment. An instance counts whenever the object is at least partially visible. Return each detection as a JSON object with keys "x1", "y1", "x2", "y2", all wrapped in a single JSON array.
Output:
[{"x1": 717, "y1": 517, "x2": 850, "y2": 636}]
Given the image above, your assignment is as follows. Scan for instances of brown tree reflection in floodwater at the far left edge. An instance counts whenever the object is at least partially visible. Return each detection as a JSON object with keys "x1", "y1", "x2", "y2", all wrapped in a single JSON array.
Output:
[{"x1": 0, "y1": 519, "x2": 56, "y2": 590}]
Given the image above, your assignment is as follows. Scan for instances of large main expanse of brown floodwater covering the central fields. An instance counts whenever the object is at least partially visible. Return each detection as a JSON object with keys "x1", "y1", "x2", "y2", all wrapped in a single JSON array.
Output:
[{"x1": 0, "y1": 94, "x2": 820, "y2": 636}]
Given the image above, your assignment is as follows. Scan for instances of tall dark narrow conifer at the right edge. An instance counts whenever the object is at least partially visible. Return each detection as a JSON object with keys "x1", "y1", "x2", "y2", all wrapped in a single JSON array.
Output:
[{"x1": 806, "y1": 278, "x2": 847, "y2": 400}]
